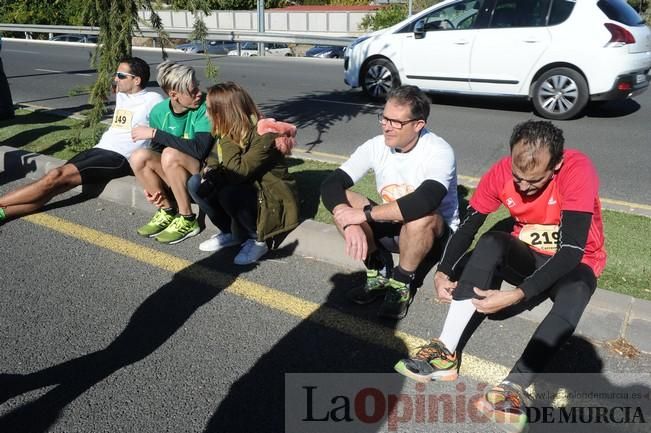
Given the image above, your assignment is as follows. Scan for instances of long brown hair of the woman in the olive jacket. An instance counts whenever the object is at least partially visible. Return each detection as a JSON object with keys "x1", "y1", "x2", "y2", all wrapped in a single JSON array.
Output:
[{"x1": 206, "y1": 81, "x2": 262, "y2": 147}]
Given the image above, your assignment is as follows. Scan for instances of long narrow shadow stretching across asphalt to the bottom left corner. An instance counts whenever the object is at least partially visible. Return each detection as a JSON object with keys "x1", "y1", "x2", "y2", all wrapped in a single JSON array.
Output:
[{"x1": 0, "y1": 247, "x2": 293, "y2": 433}]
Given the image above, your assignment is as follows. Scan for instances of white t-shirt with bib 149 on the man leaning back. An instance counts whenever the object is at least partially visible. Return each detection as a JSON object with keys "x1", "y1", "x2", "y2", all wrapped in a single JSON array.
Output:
[{"x1": 95, "y1": 90, "x2": 163, "y2": 159}]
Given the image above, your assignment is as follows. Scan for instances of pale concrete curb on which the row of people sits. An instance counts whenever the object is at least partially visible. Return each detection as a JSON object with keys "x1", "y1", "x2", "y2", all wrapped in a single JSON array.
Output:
[{"x1": 0, "y1": 146, "x2": 651, "y2": 353}]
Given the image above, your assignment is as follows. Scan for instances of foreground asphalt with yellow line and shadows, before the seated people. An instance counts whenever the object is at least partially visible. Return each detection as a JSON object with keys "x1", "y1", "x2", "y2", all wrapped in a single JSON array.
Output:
[{"x1": 0, "y1": 175, "x2": 651, "y2": 433}]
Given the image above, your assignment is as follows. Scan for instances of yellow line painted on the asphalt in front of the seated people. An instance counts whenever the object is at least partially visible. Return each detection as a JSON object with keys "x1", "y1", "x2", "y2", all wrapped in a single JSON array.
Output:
[{"x1": 23, "y1": 214, "x2": 509, "y2": 383}]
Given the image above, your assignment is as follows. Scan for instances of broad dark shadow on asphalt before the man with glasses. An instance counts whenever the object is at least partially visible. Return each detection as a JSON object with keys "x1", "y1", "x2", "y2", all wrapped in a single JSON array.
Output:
[{"x1": 204, "y1": 274, "x2": 407, "y2": 433}]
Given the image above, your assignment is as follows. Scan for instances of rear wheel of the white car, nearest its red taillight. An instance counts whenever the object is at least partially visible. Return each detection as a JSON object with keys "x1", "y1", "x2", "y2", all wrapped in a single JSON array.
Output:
[{"x1": 532, "y1": 68, "x2": 589, "y2": 120}]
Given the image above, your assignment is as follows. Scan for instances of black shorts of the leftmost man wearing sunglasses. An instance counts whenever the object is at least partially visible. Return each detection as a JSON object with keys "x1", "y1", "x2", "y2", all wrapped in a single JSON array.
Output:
[{"x1": 68, "y1": 147, "x2": 133, "y2": 185}]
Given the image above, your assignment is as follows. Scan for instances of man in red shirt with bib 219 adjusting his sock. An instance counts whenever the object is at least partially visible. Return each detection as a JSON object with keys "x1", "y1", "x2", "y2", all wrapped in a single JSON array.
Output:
[{"x1": 395, "y1": 120, "x2": 606, "y2": 432}]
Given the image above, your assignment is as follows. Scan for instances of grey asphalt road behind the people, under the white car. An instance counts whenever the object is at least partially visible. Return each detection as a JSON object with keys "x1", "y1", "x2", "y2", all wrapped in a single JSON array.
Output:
[{"x1": 2, "y1": 40, "x2": 651, "y2": 207}]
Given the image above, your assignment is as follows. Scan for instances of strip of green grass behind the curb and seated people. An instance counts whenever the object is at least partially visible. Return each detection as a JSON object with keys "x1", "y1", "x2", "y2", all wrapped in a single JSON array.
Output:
[{"x1": 0, "y1": 110, "x2": 651, "y2": 300}]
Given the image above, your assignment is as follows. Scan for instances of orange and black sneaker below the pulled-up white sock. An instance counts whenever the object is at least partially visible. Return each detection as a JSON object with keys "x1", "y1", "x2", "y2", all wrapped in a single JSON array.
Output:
[{"x1": 393, "y1": 339, "x2": 459, "y2": 383}]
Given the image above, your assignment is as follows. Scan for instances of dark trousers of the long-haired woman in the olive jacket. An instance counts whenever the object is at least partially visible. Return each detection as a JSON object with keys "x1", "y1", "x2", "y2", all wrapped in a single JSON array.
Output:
[{"x1": 187, "y1": 174, "x2": 258, "y2": 237}]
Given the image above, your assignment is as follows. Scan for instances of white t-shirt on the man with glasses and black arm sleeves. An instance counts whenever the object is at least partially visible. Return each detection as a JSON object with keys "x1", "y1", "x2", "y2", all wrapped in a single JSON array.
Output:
[{"x1": 340, "y1": 129, "x2": 459, "y2": 230}]
